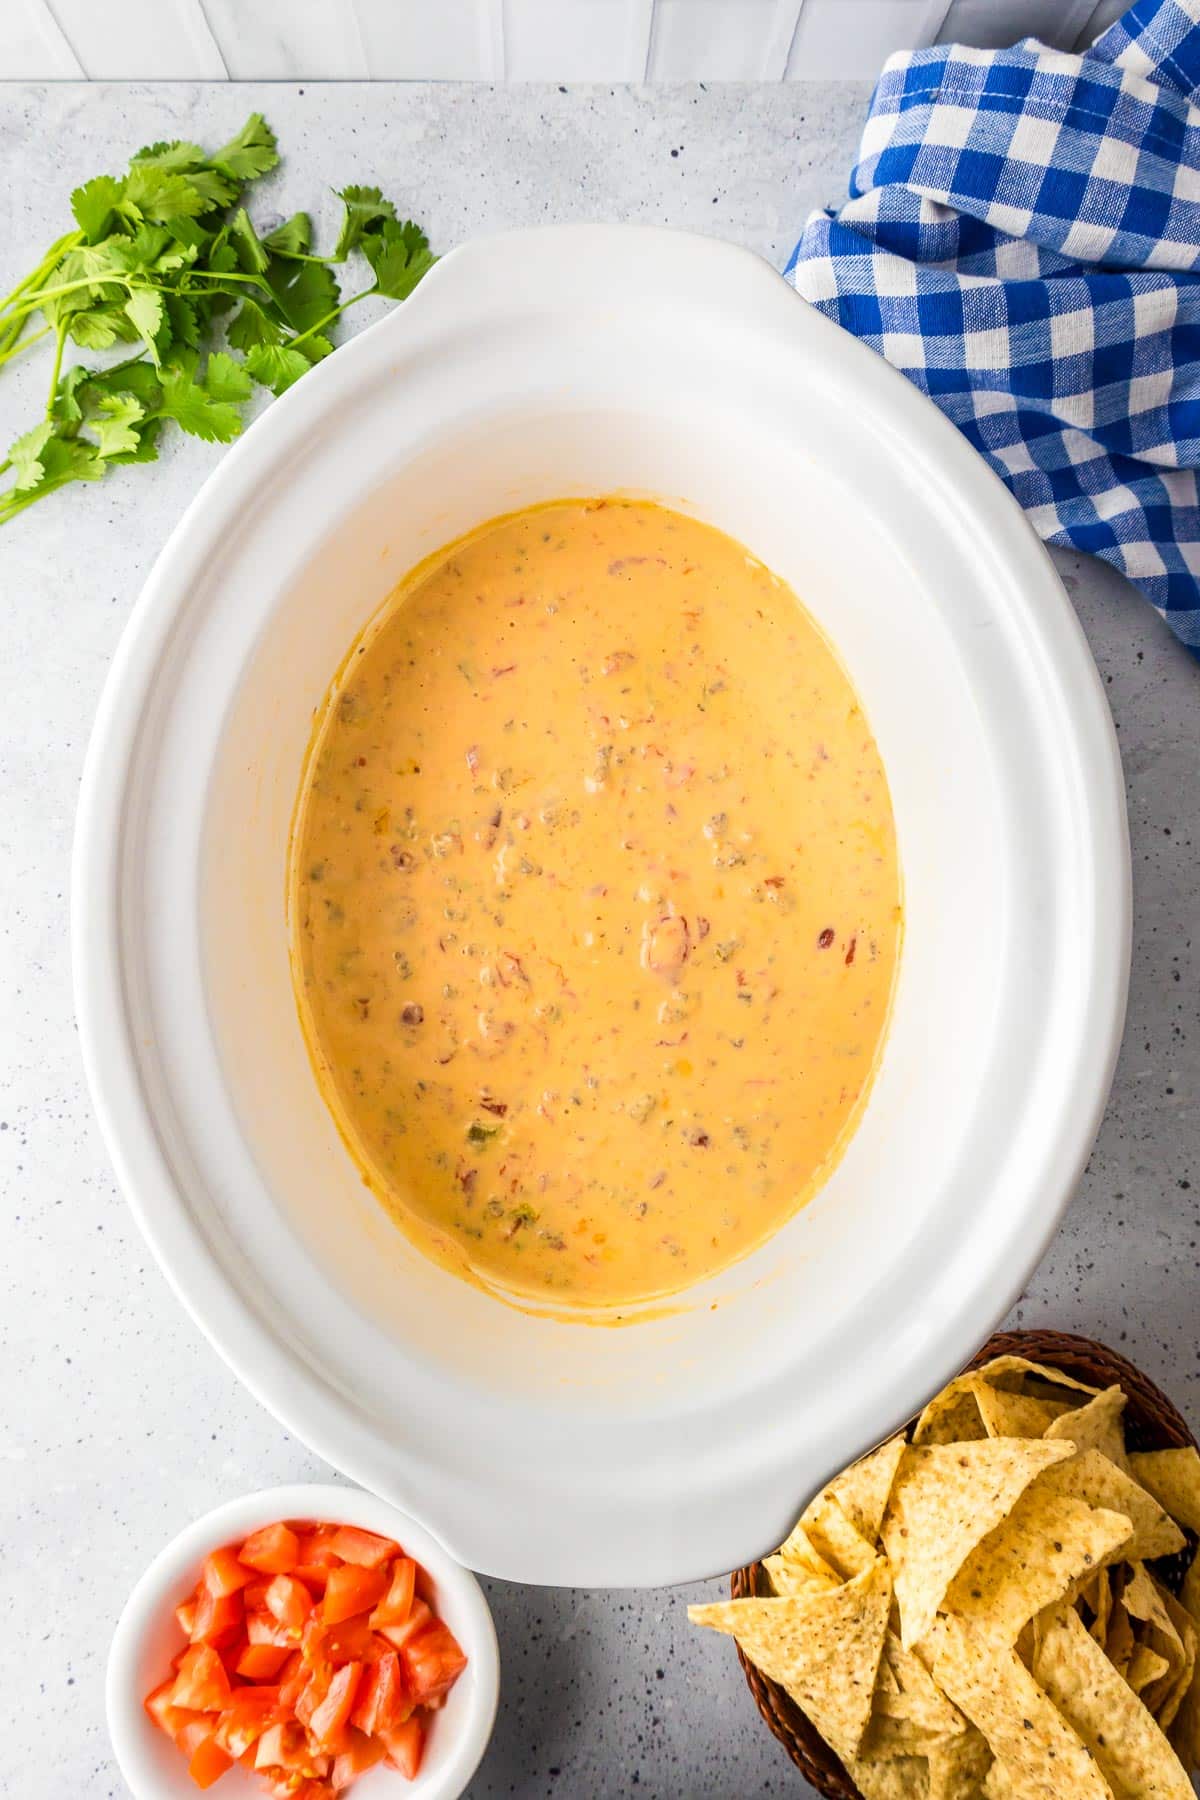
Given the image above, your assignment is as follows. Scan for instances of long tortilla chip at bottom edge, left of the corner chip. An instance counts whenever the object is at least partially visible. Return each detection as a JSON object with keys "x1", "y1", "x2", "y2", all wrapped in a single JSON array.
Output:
[{"x1": 923, "y1": 1615, "x2": 1128, "y2": 1800}]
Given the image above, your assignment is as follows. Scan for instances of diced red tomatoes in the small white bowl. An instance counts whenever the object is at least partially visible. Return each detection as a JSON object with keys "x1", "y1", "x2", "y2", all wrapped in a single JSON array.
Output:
[{"x1": 146, "y1": 1523, "x2": 466, "y2": 1800}]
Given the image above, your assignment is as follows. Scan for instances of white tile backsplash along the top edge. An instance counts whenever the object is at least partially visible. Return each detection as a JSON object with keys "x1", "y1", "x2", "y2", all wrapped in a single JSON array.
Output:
[{"x1": 0, "y1": 0, "x2": 1126, "y2": 83}]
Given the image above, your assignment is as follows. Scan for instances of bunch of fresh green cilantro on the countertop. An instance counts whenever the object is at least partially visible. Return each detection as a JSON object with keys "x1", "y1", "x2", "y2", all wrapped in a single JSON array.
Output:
[{"x1": 0, "y1": 113, "x2": 434, "y2": 524}]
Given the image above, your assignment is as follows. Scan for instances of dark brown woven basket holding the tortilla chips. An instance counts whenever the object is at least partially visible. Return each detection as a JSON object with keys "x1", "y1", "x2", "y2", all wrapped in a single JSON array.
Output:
[{"x1": 730, "y1": 1330, "x2": 1196, "y2": 1800}]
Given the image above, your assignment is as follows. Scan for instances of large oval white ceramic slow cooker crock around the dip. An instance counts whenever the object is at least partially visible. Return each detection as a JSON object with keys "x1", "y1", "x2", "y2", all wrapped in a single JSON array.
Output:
[{"x1": 74, "y1": 227, "x2": 1130, "y2": 1584}]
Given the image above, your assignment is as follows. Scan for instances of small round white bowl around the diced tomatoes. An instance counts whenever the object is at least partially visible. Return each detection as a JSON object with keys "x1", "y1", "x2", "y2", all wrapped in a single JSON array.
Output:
[{"x1": 104, "y1": 1483, "x2": 500, "y2": 1800}]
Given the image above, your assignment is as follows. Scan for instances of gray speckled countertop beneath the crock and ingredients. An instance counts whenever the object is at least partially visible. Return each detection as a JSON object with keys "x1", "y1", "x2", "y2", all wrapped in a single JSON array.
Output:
[{"x1": 0, "y1": 83, "x2": 1200, "y2": 1800}]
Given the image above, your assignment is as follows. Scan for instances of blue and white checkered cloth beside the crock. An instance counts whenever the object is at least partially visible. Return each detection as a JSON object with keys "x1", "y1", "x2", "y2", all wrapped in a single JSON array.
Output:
[{"x1": 786, "y1": 0, "x2": 1200, "y2": 653}]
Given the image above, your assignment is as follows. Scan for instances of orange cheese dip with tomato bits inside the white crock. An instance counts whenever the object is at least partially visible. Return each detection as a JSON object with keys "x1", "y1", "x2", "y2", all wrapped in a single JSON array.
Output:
[{"x1": 290, "y1": 500, "x2": 901, "y2": 1309}]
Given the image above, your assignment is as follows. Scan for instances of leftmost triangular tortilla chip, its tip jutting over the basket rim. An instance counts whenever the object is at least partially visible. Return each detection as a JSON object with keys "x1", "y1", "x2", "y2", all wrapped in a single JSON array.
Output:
[{"x1": 687, "y1": 1559, "x2": 892, "y2": 1762}]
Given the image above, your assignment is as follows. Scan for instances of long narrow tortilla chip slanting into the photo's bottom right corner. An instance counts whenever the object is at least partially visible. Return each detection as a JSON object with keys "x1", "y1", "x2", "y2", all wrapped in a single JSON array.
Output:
[{"x1": 1033, "y1": 1606, "x2": 1195, "y2": 1800}]
